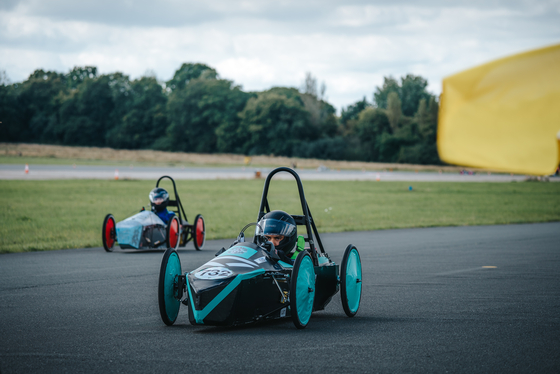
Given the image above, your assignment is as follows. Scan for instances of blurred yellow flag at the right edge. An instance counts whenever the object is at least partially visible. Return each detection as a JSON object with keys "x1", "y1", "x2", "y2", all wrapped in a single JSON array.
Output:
[{"x1": 437, "y1": 44, "x2": 560, "y2": 175}]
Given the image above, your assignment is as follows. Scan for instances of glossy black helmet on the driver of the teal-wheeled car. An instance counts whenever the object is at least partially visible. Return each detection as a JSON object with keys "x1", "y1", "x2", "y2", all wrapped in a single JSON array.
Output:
[{"x1": 257, "y1": 210, "x2": 297, "y2": 254}]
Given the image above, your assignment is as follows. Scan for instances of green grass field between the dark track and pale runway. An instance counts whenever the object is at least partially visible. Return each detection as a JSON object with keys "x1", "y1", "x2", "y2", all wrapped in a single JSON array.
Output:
[{"x1": 0, "y1": 180, "x2": 560, "y2": 253}]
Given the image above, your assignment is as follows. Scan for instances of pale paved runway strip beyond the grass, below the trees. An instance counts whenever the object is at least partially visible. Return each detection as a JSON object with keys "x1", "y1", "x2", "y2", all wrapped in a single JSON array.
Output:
[{"x1": 0, "y1": 164, "x2": 560, "y2": 182}]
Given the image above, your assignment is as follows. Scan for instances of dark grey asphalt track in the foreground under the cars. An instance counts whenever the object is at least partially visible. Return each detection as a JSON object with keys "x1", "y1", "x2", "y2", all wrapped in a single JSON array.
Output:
[{"x1": 0, "y1": 223, "x2": 560, "y2": 374}]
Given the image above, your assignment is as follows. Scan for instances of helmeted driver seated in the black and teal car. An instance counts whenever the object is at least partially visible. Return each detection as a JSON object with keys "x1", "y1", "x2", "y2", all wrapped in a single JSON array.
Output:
[{"x1": 257, "y1": 210, "x2": 297, "y2": 264}]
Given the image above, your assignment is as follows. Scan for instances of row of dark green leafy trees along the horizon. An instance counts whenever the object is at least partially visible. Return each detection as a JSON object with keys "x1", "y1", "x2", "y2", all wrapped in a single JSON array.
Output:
[{"x1": 0, "y1": 63, "x2": 441, "y2": 164}]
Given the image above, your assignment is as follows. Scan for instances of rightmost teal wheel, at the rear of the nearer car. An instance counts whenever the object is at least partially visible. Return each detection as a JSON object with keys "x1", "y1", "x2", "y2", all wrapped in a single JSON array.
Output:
[{"x1": 340, "y1": 244, "x2": 362, "y2": 317}]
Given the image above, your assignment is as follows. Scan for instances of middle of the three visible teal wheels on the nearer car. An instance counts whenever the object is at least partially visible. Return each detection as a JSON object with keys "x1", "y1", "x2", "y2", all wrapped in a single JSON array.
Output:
[{"x1": 290, "y1": 250, "x2": 315, "y2": 329}]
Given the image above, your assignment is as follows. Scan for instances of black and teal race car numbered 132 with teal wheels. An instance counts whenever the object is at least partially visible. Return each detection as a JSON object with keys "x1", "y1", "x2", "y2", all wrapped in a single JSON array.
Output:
[{"x1": 158, "y1": 167, "x2": 362, "y2": 329}]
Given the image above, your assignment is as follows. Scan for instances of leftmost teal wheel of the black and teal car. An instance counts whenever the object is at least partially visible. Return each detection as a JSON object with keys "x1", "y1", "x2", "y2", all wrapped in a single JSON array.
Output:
[{"x1": 158, "y1": 248, "x2": 181, "y2": 326}]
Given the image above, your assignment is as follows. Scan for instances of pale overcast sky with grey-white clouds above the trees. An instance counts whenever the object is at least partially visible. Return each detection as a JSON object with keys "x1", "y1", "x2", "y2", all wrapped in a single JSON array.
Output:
[{"x1": 0, "y1": 0, "x2": 560, "y2": 112}]
